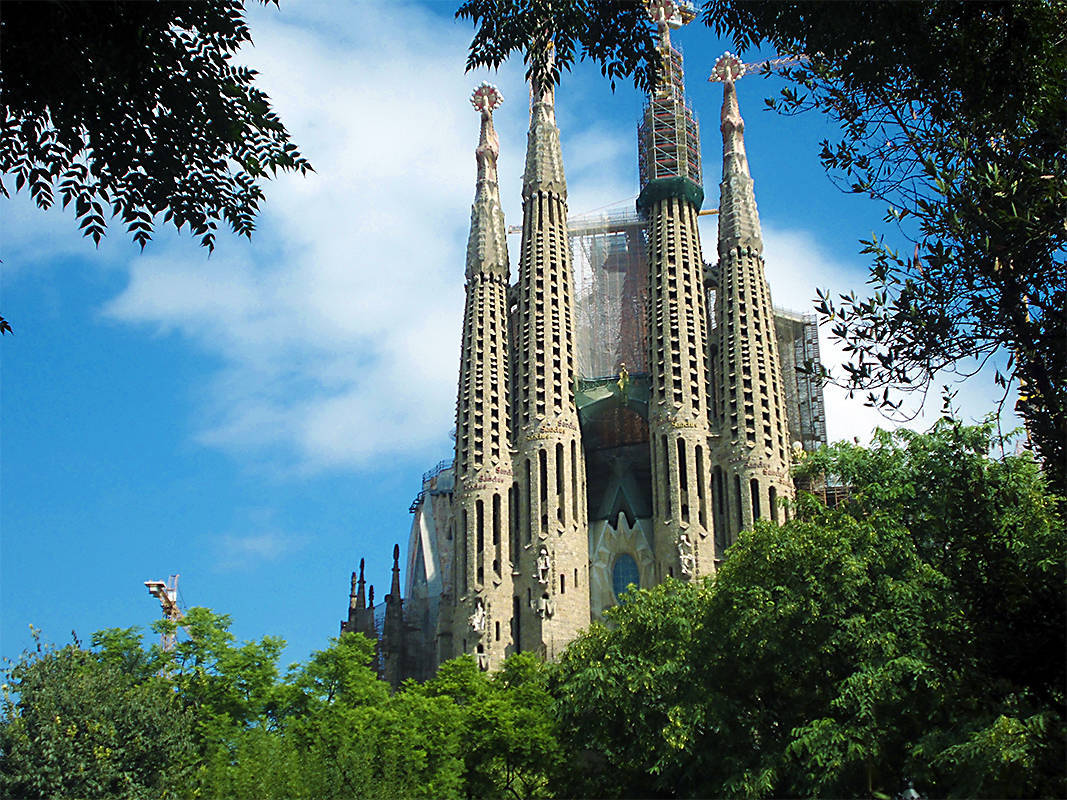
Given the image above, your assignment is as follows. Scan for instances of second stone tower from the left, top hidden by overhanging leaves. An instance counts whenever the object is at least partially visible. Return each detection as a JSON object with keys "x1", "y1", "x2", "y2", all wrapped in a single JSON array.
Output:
[{"x1": 511, "y1": 62, "x2": 589, "y2": 658}]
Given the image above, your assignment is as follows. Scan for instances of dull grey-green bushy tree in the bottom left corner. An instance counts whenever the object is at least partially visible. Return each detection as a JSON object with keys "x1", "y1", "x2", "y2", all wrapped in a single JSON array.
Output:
[{"x1": 0, "y1": 644, "x2": 195, "y2": 799}]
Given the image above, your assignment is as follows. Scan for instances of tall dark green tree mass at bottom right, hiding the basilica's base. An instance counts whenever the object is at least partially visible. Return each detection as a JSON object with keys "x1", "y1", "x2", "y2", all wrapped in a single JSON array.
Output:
[{"x1": 551, "y1": 421, "x2": 1067, "y2": 797}]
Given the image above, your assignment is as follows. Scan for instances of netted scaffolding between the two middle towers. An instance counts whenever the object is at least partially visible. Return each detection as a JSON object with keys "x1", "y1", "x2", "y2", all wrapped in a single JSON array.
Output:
[{"x1": 568, "y1": 211, "x2": 649, "y2": 380}]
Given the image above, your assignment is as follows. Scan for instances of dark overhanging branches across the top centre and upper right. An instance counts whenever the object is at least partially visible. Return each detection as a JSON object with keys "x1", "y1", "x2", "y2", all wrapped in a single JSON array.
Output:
[{"x1": 458, "y1": 0, "x2": 1067, "y2": 483}]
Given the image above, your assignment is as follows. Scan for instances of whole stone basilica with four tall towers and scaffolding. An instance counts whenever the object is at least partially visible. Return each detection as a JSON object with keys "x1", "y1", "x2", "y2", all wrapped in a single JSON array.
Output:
[{"x1": 341, "y1": 0, "x2": 826, "y2": 686}]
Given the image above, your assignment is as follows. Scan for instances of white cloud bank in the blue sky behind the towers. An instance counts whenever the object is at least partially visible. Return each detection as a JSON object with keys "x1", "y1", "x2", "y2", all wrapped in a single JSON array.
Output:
[{"x1": 77, "y1": 4, "x2": 1015, "y2": 473}]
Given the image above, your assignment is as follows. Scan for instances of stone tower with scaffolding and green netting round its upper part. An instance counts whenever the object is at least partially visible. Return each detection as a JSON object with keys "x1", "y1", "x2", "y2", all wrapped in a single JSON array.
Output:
[{"x1": 638, "y1": 0, "x2": 715, "y2": 580}]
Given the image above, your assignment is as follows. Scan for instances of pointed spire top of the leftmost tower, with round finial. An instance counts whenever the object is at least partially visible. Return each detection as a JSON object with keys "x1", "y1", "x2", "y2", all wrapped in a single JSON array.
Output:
[{"x1": 466, "y1": 83, "x2": 509, "y2": 278}]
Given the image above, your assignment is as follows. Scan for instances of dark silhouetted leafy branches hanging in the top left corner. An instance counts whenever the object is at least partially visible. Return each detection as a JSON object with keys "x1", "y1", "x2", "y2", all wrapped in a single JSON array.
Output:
[{"x1": 0, "y1": 0, "x2": 310, "y2": 250}]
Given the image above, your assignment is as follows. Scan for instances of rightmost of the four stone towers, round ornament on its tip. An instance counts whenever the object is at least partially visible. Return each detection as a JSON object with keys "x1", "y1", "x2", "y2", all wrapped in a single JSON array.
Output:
[{"x1": 712, "y1": 53, "x2": 793, "y2": 545}]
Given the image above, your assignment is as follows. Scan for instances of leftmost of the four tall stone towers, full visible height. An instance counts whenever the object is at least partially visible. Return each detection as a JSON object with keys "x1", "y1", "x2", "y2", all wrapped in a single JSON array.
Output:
[{"x1": 437, "y1": 83, "x2": 511, "y2": 669}]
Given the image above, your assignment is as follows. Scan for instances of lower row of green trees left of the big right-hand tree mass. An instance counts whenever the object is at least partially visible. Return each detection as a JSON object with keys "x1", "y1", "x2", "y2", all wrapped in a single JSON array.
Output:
[{"x1": 0, "y1": 608, "x2": 561, "y2": 800}]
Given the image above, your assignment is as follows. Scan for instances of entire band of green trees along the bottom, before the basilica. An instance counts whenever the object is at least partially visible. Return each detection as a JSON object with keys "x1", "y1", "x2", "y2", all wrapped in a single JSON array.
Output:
[{"x1": 0, "y1": 421, "x2": 1067, "y2": 799}]
